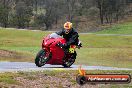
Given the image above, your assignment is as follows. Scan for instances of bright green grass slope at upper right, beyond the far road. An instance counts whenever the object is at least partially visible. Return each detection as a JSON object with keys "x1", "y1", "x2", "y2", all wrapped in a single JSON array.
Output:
[{"x1": 97, "y1": 22, "x2": 132, "y2": 34}]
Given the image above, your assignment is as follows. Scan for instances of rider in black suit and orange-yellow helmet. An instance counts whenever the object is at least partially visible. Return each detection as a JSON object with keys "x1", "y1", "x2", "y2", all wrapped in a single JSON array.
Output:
[{"x1": 56, "y1": 22, "x2": 79, "y2": 49}]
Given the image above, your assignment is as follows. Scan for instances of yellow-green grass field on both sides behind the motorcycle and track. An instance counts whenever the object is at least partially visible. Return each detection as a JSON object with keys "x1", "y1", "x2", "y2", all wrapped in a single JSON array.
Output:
[{"x1": 0, "y1": 29, "x2": 132, "y2": 68}]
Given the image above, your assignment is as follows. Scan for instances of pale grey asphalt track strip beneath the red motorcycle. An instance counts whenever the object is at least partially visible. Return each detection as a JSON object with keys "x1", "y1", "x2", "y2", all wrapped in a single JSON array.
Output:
[{"x1": 0, "y1": 62, "x2": 132, "y2": 72}]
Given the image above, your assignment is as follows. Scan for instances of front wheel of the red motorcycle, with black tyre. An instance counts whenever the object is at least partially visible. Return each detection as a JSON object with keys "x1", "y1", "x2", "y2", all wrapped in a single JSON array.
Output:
[{"x1": 35, "y1": 49, "x2": 49, "y2": 67}]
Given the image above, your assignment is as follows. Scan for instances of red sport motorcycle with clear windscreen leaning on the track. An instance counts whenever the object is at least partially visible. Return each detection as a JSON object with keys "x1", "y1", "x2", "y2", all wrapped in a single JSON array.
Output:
[{"x1": 35, "y1": 33, "x2": 81, "y2": 67}]
